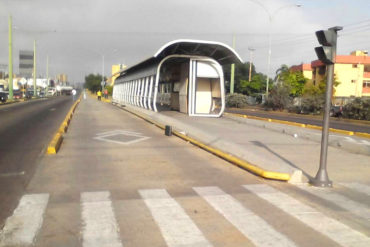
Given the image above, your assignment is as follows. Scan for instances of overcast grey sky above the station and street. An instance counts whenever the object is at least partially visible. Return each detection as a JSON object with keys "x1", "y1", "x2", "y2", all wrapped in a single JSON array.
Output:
[{"x1": 0, "y1": 0, "x2": 370, "y2": 81}]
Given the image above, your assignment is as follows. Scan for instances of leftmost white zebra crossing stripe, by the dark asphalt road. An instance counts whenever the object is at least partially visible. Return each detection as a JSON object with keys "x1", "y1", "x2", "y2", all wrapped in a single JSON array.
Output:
[{"x1": 0, "y1": 194, "x2": 49, "y2": 246}]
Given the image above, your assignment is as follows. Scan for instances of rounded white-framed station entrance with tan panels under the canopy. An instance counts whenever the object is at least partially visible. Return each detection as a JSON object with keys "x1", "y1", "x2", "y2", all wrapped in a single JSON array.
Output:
[{"x1": 157, "y1": 57, "x2": 225, "y2": 116}]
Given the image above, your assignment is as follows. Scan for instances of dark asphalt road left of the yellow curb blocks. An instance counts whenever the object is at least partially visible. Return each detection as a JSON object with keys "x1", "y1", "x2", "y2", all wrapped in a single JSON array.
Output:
[{"x1": 0, "y1": 96, "x2": 73, "y2": 225}]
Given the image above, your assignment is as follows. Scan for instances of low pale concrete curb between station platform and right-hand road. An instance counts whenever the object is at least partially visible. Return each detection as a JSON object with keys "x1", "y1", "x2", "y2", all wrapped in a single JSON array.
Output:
[{"x1": 224, "y1": 113, "x2": 370, "y2": 155}]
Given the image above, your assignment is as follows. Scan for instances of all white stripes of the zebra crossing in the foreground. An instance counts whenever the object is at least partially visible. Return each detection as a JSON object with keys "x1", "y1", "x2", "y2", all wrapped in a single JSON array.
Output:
[{"x1": 0, "y1": 184, "x2": 370, "y2": 247}]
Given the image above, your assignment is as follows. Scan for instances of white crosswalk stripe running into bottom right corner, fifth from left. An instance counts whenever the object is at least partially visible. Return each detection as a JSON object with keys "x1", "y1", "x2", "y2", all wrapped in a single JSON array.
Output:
[{"x1": 244, "y1": 184, "x2": 370, "y2": 247}]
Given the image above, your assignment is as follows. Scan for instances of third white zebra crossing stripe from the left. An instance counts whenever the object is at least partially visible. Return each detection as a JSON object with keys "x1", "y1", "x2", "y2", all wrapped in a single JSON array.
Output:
[{"x1": 139, "y1": 189, "x2": 212, "y2": 247}]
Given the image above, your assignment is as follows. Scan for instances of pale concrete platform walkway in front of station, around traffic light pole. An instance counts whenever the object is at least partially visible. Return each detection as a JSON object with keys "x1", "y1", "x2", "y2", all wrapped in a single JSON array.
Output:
[{"x1": 118, "y1": 106, "x2": 370, "y2": 183}]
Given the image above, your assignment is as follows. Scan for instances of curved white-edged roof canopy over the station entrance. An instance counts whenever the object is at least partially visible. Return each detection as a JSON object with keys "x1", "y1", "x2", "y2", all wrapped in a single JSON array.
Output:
[{"x1": 117, "y1": 39, "x2": 243, "y2": 81}]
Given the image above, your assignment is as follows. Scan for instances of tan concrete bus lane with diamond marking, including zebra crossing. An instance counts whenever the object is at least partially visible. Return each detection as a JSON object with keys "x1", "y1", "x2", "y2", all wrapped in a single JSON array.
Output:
[{"x1": 0, "y1": 95, "x2": 370, "y2": 247}]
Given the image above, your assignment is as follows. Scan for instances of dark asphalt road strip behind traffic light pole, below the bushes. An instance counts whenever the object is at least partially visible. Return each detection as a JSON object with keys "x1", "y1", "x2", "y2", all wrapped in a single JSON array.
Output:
[{"x1": 226, "y1": 109, "x2": 370, "y2": 133}]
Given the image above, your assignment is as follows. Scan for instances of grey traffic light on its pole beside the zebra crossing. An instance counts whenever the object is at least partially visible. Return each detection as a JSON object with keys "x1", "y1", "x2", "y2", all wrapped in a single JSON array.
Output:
[{"x1": 310, "y1": 27, "x2": 343, "y2": 187}]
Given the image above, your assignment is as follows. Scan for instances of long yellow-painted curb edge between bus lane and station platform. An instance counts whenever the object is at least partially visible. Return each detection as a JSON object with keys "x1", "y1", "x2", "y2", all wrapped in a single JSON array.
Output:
[{"x1": 117, "y1": 107, "x2": 291, "y2": 181}]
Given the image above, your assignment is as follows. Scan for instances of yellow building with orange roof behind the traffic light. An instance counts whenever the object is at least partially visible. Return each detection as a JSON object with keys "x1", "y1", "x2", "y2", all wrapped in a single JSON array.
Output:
[{"x1": 291, "y1": 51, "x2": 370, "y2": 101}]
